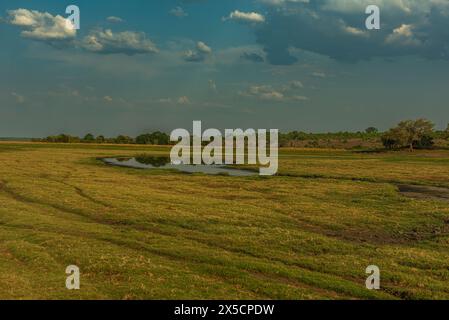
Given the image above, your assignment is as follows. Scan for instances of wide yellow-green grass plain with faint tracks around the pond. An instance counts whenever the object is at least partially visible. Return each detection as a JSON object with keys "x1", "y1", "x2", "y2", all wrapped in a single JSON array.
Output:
[{"x1": 0, "y1": 142, "x2": 449, "y2": 299}]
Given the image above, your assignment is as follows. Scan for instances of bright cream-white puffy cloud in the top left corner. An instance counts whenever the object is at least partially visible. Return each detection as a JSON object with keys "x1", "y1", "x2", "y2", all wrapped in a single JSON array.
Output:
[{"x1": 7, "y1": 9, "x2": 76, "y2": 44}]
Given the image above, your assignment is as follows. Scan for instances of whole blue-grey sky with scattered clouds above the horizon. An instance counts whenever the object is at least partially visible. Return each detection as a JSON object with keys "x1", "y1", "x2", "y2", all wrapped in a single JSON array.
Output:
[{"x1": 0, "y1": 0, "x2": 449, "y2": 137}]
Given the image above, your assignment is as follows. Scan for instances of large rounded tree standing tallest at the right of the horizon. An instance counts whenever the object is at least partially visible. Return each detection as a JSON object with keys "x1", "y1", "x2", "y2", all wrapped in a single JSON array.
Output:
[{"x1": 382, "y1": 119, "x2": 435, "y2": 151}]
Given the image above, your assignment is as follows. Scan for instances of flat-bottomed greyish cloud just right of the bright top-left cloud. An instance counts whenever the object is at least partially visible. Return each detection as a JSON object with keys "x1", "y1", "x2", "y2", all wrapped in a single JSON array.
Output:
[{"x1": 81, "y1": 29, "x2": 158, "y2": 55}]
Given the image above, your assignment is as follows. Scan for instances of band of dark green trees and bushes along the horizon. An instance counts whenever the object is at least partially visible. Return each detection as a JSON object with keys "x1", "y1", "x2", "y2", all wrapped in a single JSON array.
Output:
[{"x1": 33, "y1": 119, "x2": 449, "y2": 150}]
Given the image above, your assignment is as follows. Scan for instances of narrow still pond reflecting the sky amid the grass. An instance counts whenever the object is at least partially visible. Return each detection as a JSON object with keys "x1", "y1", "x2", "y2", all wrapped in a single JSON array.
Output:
[{"x1": 103, "y1": 156, "x2": 258, "y2": 177}]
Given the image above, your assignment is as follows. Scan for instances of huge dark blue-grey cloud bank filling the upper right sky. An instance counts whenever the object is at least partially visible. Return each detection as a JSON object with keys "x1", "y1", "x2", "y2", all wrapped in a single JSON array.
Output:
[{"x1": 254, "y1": 0, "x2": 449, "y2": 65}]
